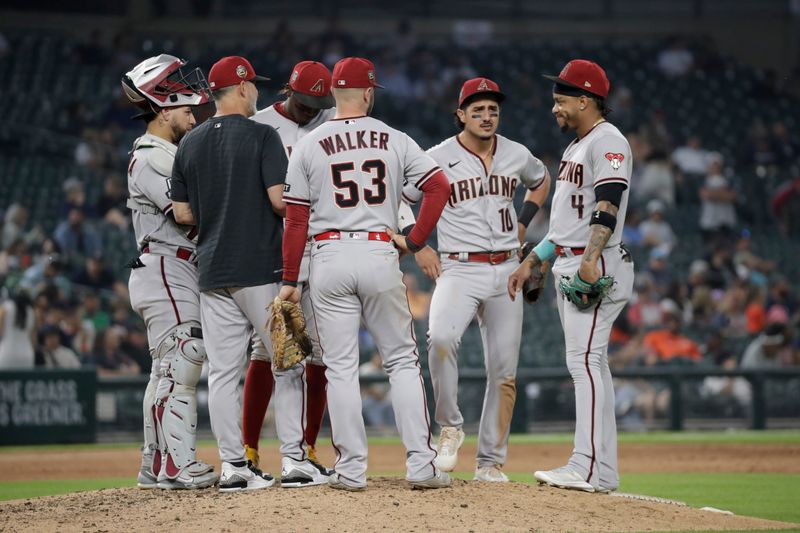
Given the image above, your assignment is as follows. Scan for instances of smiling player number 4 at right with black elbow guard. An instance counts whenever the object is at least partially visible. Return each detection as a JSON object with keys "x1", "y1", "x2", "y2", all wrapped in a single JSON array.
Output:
[{"x1": 508, "y1": 59, "x2": 633, "y2": 492}]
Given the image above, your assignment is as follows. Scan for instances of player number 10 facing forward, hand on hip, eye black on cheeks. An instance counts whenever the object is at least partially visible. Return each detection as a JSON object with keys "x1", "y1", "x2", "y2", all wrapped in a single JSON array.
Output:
[{"x1": 410, "y1": 78, "x2": 550, "y2": 482}]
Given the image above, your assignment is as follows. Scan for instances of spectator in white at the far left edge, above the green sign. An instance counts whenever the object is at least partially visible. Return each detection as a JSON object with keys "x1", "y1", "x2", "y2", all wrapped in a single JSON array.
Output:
[{"x1": 0, "y1": 291, "x2": 36, "y2": 370}]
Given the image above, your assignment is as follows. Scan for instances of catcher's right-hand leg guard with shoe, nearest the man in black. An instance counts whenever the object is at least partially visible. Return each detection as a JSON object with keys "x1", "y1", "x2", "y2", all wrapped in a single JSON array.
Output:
[{"x1": 152, "y1": 323, "x2": 217, "y2": 488}]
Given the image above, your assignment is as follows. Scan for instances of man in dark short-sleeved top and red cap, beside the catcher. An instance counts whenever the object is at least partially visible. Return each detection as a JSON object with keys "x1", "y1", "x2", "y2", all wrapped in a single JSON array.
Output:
[{"x1": 172, "y1": 56, "x2": 328, "y2": 492}]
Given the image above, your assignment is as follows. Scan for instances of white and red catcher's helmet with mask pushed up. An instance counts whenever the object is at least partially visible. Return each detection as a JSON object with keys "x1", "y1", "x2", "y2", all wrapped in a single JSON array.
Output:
[{"x1": 122, "y1": 54, "x2": 211, "y2": 118}]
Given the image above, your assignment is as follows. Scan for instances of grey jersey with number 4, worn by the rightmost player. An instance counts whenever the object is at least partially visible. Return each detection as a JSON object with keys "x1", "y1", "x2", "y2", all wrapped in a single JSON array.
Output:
[{"x1": 547, "y1": 122, "x2": 633, "y2": 248}]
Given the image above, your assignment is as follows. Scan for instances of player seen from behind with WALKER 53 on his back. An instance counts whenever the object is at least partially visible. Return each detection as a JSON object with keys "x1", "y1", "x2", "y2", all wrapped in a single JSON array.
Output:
[{"x1": 280, "y1": 57, "x2": 451, "y2": 490}]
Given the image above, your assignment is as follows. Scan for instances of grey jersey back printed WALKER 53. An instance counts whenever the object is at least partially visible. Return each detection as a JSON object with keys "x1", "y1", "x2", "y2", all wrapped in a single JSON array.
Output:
[{"x1": 283, "y1": 117, "x2": 439, "y2": 235}]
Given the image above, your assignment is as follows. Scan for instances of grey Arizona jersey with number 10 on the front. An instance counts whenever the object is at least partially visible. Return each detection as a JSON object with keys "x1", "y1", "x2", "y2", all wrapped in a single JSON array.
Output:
[{"x1": 406, "y1": 135, "x2": 545, "y2": 252}]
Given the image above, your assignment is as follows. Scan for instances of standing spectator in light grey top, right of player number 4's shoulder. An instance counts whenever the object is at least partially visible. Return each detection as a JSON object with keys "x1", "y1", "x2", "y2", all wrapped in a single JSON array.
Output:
[{"x1": 700, "y1": 155, "x2": 736, "y2": 240}]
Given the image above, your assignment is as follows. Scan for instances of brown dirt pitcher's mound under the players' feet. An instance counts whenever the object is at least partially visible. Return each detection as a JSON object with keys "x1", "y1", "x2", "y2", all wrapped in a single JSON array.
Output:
[{"x1": 0, "y1": 478, "x2": 792, "y2": 533}]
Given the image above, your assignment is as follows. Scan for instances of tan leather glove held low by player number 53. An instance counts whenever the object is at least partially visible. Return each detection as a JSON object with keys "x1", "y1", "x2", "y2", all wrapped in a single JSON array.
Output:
[{"x1": 269, "y1": 298, "x2": 311, "y2": 370}]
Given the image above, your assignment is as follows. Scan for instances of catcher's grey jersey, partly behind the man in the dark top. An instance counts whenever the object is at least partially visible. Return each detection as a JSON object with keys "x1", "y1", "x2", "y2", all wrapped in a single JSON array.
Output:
[{"x1": 128, "y1": 133, "x2": 197, "y2": 250}]
